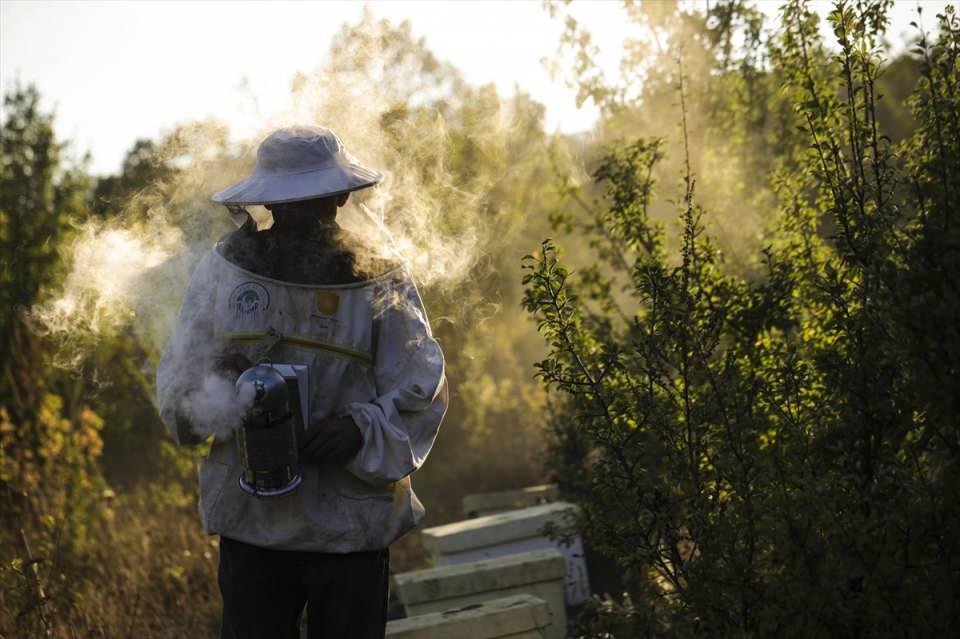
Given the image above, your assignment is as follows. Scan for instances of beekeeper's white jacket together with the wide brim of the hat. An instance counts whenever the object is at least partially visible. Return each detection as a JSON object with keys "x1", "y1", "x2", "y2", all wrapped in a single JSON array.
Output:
[{"x1": 157, "y1": 126, "x2": 447, "y2": 553}]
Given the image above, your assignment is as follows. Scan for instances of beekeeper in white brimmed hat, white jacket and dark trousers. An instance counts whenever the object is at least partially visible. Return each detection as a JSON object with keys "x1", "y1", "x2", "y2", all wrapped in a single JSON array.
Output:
[{"x1": 157, "y1": 126, "x2": 447, "y2": 639}]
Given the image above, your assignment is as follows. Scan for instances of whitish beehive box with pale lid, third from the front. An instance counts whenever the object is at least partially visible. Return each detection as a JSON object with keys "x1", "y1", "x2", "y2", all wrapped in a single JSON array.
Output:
[{"x1": 421, "y1": 502, "x2": 590, "y2": 605}]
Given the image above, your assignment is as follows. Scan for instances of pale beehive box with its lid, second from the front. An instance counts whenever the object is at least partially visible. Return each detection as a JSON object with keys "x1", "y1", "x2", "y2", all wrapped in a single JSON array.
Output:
[{"x1": 394, "y1": 548, "x2": 567, "y2": 639}]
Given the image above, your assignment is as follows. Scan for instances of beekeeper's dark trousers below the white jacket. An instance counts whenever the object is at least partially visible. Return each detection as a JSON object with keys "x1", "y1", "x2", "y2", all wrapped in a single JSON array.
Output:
[{"x1": 219, "y1": 537, "x2": 390, "y2": 639}]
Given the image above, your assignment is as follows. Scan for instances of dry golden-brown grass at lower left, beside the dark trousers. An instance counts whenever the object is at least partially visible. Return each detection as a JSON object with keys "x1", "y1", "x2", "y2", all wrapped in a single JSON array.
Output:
[{"x1": 0, "y1": 487, "x2": 219, "y2": 639}]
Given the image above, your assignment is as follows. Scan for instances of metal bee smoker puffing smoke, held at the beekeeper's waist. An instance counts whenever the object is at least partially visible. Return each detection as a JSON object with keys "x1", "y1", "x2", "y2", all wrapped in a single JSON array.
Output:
[{"x1": 236, "y1": 364, "x2": 307, "y2": 497}]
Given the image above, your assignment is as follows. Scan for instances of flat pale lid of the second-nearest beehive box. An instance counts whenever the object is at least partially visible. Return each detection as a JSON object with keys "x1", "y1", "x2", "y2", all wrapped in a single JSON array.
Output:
[{"x1": 394, "y1": 548, "x2": 566, "y2": 606}]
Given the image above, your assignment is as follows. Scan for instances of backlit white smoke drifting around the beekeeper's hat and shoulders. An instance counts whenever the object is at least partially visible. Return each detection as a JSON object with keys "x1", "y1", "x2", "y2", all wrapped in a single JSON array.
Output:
[{"x1": 30, "y1": 14, "x2": 511, "y2": 436}]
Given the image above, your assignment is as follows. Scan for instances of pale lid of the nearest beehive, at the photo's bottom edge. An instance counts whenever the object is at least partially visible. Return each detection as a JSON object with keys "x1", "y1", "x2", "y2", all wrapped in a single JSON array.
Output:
[{"x1": 387, "y1": 595, "x2": 551, "y2": 639}]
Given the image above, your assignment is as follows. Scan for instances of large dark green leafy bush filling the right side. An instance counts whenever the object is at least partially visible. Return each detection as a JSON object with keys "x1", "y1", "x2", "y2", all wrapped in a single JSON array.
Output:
[{"x1": 524, "y1": 2, "x2": 960, "y2": 637}]
